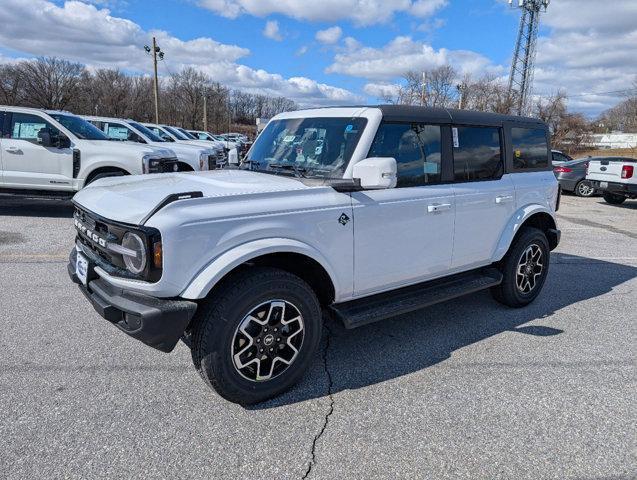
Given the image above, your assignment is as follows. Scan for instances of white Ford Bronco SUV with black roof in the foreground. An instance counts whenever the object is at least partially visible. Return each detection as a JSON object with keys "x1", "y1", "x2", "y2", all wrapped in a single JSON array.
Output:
[{"x1": 68, "y1": 106, "x2": 560, "y2": 404}]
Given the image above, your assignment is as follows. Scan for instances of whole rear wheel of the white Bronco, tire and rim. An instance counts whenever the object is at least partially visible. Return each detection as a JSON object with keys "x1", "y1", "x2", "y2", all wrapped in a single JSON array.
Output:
[{"x1": 491, "y1": 227, "x2": 550, "y2": 308}]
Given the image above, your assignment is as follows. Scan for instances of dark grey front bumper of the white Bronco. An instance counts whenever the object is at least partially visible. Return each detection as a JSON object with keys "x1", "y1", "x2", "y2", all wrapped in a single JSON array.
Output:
[{"x1": 67, "y1": 249, "x2": 197, "y2": 352}]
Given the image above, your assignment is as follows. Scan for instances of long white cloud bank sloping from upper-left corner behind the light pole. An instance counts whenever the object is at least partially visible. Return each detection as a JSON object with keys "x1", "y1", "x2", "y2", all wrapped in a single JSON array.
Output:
[{"x1": 0, "y1": 0, "x2": 362, "y2": 105}]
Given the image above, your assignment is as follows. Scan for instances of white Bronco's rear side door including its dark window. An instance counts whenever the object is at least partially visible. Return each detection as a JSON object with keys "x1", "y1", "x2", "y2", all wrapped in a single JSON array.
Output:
[{"x1": 451, "y1": 125, "x2": 515, "y2": 270}]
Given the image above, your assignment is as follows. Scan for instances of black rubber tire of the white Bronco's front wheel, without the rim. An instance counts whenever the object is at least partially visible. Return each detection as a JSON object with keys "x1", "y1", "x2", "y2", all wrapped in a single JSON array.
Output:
[{"x1": 186, "y1": 267, "x2": 323, "y2": 405}]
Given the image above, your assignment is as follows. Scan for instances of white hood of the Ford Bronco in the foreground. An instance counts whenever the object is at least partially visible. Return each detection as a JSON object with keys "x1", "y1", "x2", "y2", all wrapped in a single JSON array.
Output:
[{"x1": 73, "y1": 170, "x2": 313, "y2": 225}]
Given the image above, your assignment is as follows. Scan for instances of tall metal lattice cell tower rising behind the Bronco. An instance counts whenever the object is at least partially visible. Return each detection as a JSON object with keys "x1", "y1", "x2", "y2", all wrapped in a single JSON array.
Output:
[{"x1": 509, "y1": 0, "x2": 550, "y2": 115}]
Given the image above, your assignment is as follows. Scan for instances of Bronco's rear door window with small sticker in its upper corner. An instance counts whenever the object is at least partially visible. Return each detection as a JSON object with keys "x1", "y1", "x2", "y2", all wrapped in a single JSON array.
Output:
[{"x1": 452, "y1": 127, "x2": 503, "y2": 182}]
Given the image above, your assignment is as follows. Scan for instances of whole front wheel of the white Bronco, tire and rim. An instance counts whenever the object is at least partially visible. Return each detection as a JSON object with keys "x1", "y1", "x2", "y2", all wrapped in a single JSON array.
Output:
[{"x1": 191, "y1": 267, "x2": 323, "y2": 405}]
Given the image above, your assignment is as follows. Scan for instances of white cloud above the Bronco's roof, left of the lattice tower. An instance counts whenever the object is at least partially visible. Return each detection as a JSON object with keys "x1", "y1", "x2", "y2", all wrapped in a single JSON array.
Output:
[{"x1": 326, "y1": 36, "x2": 502, "y2": 82}]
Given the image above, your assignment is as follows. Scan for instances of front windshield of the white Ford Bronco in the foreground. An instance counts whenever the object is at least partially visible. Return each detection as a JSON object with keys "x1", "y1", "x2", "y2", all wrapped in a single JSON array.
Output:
[{"x1": 247, "y1": 117, "x2": 367, "y2": 178}]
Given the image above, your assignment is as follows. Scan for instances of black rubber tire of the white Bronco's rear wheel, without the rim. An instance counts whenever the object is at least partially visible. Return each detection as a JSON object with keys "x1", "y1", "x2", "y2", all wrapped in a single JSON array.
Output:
[{"x1": 491, "y1": 227, "x2": 550, "y2": 308}]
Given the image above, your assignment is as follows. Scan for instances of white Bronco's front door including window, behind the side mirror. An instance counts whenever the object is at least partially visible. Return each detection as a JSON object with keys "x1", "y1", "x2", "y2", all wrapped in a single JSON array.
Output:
[{"x1": 352, "y1": 123, "x2": 455, "y2": 296}]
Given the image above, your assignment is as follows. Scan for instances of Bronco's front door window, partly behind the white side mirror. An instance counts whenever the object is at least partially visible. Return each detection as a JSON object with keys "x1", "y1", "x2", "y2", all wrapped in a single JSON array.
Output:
[{"x1": 369, "y1": 123, "x2": 442, "y2": 187}]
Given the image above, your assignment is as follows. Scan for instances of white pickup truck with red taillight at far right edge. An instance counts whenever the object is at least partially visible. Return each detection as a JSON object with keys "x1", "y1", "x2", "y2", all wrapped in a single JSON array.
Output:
[{"x1": 586, "y1": 157, "x2": 637, "y2": 205}]
